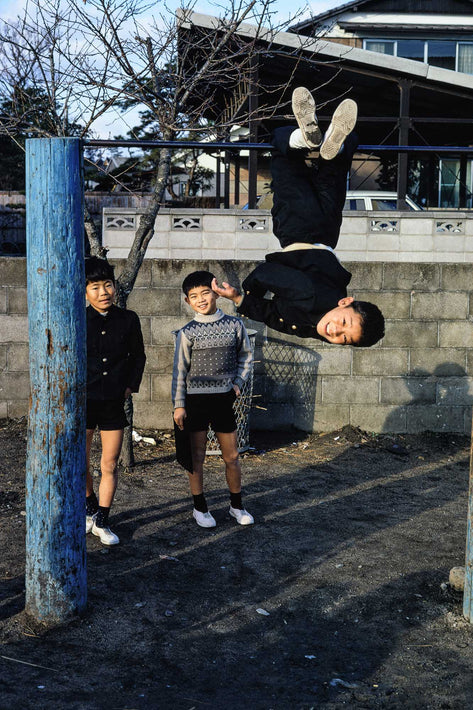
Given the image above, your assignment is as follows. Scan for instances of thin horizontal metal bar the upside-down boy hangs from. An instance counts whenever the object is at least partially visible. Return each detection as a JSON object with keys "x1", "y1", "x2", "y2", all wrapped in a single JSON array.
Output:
[{"x1": 84, "y1": 139, "x2": 473, "y2": 154}]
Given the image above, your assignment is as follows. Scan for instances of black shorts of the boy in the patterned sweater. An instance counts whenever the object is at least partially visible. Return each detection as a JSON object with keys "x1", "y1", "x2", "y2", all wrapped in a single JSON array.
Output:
[{"x1": 186, "y1": 388, "x2": 236, "y2": 434}]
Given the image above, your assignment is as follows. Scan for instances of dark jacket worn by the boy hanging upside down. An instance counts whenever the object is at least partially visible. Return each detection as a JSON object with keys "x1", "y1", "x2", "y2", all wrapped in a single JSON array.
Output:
[{"x1": 237, "y1": 249, "x2": 351, "y2": 340}]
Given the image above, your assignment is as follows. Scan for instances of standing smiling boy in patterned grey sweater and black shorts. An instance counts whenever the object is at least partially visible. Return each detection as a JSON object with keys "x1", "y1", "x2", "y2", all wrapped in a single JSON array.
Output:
[{"x1": 172, "y1": 271, "x2": 254, "y2": 528}]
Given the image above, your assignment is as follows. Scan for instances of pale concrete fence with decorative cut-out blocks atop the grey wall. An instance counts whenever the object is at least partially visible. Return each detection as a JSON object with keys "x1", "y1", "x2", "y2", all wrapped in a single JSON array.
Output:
[{"x1": 103, "y1": 208, "x2": 473, "y2": 263}]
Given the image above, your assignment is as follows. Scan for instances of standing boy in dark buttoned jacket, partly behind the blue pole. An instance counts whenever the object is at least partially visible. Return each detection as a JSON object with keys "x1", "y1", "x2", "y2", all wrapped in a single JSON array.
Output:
[{"x1": 85, "y1": 256, "x2": 146, "y2": 545}]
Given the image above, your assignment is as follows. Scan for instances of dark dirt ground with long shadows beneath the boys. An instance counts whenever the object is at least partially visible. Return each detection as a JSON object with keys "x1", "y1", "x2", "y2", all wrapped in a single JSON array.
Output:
[{"x1": 0, "y1": 421, "x2": 473, "y2": 710}]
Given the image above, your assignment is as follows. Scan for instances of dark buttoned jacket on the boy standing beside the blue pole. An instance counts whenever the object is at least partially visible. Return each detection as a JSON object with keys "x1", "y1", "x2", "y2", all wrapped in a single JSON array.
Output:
[{"x1": 86, "y1": 306, "x2": 146, "y2": 400}]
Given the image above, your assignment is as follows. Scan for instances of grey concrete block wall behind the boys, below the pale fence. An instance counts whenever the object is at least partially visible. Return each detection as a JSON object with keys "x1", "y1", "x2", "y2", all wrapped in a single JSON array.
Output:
[{"x1": 0, "y1": 258, "x2": 473, "y2": 434}]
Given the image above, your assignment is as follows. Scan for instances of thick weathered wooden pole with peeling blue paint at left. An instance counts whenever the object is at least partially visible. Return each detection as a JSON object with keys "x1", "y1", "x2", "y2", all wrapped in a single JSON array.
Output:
[{"x1": 26, "y1": 138, "x2": 87, "y2": 625}]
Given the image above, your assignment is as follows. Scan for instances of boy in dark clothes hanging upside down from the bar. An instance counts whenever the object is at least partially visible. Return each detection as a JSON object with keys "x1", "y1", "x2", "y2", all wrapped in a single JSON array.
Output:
[{"x1": 212, "y1": 87, "x2": 384, "y2": 346}]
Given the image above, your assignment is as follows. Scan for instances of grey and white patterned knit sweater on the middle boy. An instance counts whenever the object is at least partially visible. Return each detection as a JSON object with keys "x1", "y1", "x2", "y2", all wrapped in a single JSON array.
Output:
[{"x1": 172, "y1": 308, "x2": 253, "y2": 409}]
